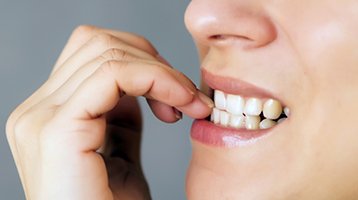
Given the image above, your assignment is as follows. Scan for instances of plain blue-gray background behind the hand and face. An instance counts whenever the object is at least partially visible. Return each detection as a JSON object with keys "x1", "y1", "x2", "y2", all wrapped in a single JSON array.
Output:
[{"x1": 0, "y1": 0, "x2": 199, "y2": 200}]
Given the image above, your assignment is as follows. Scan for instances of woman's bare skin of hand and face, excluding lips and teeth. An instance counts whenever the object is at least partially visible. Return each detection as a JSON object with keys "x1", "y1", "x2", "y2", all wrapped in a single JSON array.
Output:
[{"x1": 7, "y1": 0, "x2": 358, "y2": 200}]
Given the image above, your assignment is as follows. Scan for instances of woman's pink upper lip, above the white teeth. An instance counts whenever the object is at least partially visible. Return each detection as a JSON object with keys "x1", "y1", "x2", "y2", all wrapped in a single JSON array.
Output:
[{"x1": 201, "y1": 67, "x2": 283, "y2": 103}]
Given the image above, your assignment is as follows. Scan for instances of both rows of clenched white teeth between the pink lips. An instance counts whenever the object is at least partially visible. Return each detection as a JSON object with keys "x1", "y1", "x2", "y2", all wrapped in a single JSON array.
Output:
[{"x1": 210, "y1": 90, "x2": 290, "y2": 130}]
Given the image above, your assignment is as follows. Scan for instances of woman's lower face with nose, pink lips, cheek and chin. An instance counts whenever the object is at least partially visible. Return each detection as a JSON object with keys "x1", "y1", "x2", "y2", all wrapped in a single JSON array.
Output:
[{"x1": 185, "y1": 0, "x2": 358, "y2": 200}]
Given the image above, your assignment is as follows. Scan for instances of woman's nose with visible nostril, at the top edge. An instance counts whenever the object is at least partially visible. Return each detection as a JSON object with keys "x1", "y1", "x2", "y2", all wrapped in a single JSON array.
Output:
[{"x1": 185, "y1": 0, "x2": 277, "y2": 48}]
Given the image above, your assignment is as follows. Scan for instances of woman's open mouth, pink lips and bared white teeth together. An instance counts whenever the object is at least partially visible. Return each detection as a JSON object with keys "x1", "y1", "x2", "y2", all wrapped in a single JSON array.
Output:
[{"x1": 191, "y1": 69, "x2": 290, "y2": 147}]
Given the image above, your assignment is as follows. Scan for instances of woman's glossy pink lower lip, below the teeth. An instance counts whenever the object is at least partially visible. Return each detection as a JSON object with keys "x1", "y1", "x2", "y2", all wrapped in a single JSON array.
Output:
[{"x1": 191, "y1": 120, "x2": 272, "y2": 148}]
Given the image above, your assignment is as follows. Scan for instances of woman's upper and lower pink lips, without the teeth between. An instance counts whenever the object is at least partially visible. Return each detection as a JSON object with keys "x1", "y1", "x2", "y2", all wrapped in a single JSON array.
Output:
[{"x1": 191, "y1": 68, "x2": 284, "y2": 148}]
